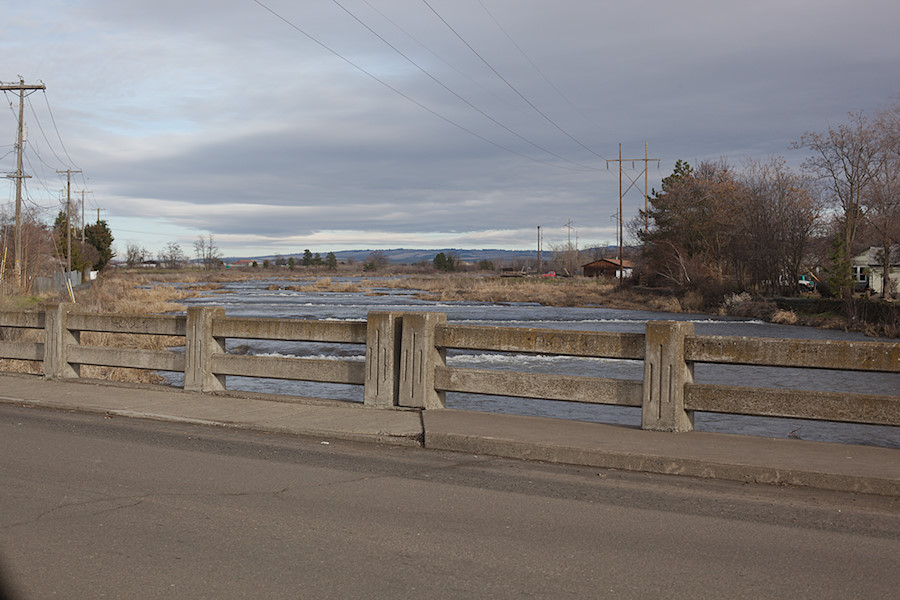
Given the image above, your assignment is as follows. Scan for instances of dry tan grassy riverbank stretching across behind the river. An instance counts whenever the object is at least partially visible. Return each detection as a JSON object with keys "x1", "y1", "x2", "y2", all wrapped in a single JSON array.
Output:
[{"x1": 0, "y1": 269, "x2": 900, "y2": 338}]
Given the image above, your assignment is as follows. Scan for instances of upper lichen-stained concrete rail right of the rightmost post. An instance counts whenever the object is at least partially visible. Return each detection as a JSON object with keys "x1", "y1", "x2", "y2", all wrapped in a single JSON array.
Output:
[{"x1": 684, "y1": 335, "x2": 900, "y2": 373}]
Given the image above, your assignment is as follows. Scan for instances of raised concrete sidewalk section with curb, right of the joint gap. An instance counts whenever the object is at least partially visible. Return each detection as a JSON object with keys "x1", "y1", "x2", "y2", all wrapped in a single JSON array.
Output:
[{"x1": 423, "y1": 410, "x2": 900, "y2": 497}]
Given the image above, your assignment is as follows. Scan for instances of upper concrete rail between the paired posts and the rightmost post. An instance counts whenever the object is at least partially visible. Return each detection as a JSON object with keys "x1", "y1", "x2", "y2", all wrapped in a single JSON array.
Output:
[{"x1": 435, "y1": 325, "x2": 644, "y2": 360}]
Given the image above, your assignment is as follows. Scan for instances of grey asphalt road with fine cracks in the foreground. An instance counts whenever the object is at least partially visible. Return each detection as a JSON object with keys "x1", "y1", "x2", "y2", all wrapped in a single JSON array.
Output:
[{"x1": 0, "y1": 406, "x2": 900, "y2": 599}]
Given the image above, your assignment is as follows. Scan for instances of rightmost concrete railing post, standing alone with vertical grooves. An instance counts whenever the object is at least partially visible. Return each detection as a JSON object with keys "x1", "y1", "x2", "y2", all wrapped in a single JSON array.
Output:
[{"x1": 641, "y1": 321, "x2": 694, "y2": 431}]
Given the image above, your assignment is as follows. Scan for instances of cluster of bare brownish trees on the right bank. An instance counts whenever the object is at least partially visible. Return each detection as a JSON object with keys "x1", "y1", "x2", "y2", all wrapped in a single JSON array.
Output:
[{"x1": 630, "y1": 105, "x2": 900, "y2": 297}]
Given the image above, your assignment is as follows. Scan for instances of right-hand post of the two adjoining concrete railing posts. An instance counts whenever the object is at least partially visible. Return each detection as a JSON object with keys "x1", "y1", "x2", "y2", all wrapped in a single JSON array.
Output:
[{"x1": 398, "y1": 313, "x2": 447, "y2": 409}]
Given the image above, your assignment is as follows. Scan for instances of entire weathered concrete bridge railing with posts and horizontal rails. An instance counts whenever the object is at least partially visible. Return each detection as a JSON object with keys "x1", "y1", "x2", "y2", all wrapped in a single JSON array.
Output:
[{"x1": 0, "y1": 304, "x2": 900, "y2": 431}]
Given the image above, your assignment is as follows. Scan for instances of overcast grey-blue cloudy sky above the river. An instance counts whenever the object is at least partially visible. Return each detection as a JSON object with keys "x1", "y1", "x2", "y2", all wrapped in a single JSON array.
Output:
[{"x1": 0, "y1": 0, "x2": 900, "y2": 256}]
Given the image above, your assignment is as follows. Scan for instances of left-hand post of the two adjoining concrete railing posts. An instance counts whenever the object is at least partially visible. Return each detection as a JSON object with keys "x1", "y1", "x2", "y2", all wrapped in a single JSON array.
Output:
[{"x1": 363, "y1": 311, "x2": 403, "y2": 408}]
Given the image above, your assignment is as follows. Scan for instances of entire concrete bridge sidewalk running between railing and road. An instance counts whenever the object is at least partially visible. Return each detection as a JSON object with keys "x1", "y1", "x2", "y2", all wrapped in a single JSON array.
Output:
[{"x1": 0, "y1": 375, "x2": 900, "y2": 497}]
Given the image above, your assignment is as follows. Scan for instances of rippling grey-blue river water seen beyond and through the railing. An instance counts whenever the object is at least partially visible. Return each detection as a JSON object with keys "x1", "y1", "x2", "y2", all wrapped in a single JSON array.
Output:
[{"x1": 166, "y1": 278, "x2": 900, "y2": 448}]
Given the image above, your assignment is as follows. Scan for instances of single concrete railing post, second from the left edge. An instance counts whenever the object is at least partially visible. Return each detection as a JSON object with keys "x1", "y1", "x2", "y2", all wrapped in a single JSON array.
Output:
[{"x1": 184, "y1": 306, "x2": 225, "y2": 392}]
